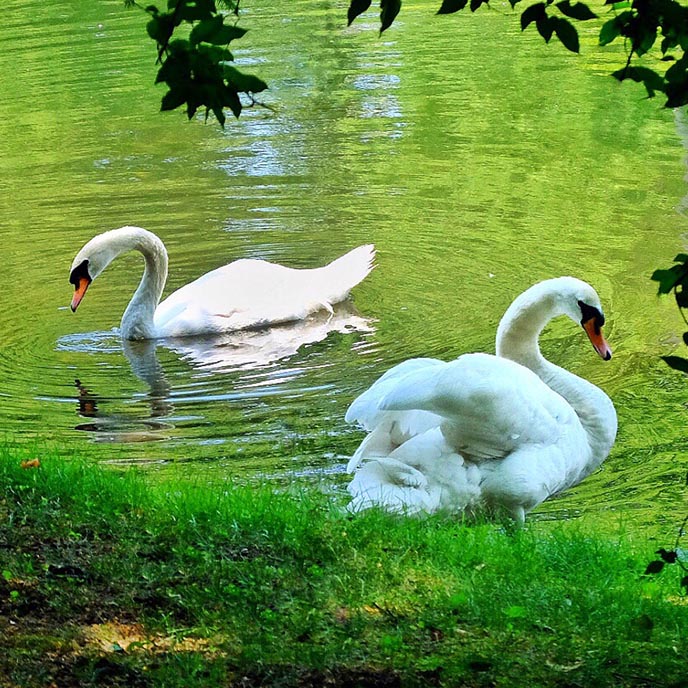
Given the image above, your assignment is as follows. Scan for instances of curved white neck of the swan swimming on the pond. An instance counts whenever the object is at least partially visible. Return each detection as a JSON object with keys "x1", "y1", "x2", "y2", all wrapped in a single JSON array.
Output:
[{"x1": 99, "y1": 227, "x2": 167, "y2": 339}]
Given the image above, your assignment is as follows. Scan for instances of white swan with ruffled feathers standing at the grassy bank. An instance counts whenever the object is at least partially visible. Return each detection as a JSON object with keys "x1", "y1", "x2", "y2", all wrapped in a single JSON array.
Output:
[{"x1": 345, "y1": 277, "x2": 617, "y2": 524}]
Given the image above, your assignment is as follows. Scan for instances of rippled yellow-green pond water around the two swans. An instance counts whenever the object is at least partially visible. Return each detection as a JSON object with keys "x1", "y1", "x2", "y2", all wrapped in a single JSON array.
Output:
[{"x1": 0, "y1": 0, "x2": 688, "y2": 529}]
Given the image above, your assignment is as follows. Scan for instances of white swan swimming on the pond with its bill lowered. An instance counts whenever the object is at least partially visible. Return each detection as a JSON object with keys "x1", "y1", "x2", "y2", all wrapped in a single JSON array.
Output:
[{"x1": 69, "y1": 226, "x2": 375, "y2": 340}]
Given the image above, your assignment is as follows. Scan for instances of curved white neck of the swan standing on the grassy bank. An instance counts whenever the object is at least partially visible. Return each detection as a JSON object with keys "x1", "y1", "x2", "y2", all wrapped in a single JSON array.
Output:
[{"x1": 496, "y1": 278, "x2": 617, "y2": 467}]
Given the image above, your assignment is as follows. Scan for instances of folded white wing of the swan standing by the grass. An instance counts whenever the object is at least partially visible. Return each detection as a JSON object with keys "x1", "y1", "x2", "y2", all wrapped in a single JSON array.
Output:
[{"x1": 379, "y1": 354, "x2": 580, "y2": 460}]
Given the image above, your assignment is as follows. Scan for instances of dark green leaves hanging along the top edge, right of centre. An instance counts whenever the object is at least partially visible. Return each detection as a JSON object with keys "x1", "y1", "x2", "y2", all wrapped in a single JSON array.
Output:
[{"x1": 348, "y1": 0, "x2": 688, "y2": 108}]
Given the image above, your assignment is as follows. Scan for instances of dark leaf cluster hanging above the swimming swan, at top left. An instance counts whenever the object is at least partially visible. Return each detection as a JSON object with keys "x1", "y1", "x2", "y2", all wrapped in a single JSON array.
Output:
[{"x1": 136, "y1": 0, "x2": 267, "y2": 126}]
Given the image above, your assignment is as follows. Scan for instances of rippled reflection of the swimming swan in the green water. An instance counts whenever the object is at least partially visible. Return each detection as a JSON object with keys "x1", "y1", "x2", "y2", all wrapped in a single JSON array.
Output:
[{"x1": 67, "y1": 302, "x2": 374, "y2": 443}]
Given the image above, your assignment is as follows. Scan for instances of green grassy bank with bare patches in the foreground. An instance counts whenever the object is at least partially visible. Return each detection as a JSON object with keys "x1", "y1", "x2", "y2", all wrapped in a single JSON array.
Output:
[{"x1": 0, "y1": 448, "x2": 688, "y2": 688}]
